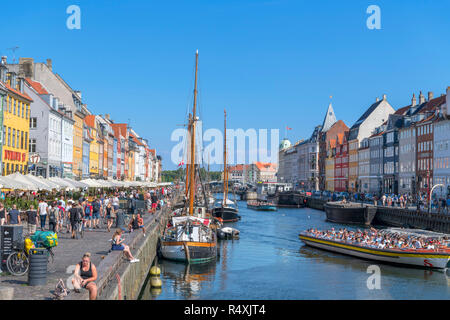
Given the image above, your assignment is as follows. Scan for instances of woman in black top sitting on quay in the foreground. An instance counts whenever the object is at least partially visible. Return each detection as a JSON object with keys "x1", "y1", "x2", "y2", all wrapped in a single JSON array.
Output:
[{"x1": 72, "y1": 252, "x2": 97, "y2": 300}]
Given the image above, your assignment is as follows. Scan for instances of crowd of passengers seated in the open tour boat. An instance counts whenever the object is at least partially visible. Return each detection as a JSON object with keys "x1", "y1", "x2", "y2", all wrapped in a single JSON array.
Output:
[{"x1": 306, "y1": 228, "x2": 450, "y2": 251}]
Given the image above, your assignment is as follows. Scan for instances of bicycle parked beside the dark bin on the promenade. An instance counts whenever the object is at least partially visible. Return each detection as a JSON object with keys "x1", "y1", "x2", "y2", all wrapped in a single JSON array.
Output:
[{"x1": 6, "y1": 242, "x2": 55, "y2": 276}]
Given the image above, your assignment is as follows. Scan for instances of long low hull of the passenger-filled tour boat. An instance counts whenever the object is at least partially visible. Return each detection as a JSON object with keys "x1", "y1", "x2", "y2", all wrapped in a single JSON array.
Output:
[{"x1": 299, "y1": 233, "x2": 450, "y2": 269}]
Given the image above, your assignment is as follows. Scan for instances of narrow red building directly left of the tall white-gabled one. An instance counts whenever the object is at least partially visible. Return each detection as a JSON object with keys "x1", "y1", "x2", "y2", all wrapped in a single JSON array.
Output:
[{"x1": 334, "y1": 131, "x2": 348, "y2": 192}]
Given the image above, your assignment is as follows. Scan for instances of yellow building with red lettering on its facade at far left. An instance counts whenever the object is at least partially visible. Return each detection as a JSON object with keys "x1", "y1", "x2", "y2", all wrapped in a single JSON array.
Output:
[{"x1": 2, "y1": 70, "x2": 31, "y2": 175}]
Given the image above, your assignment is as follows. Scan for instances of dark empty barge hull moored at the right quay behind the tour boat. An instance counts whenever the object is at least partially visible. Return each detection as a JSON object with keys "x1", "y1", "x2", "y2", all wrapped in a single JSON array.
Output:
[{"x1": 324, "y1": 202, "x2": 377, "y2": 225}]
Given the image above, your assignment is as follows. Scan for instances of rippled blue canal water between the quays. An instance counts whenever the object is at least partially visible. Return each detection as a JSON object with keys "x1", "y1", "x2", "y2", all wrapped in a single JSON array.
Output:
[{"x1": 141, "y1": 201, "x2": 450, "y2": 300}]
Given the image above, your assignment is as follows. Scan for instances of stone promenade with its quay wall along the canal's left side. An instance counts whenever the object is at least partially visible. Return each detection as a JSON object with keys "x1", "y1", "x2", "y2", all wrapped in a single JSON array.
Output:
[{"x1": 0, "y1": 194, "x2": 176, "y2": 300}]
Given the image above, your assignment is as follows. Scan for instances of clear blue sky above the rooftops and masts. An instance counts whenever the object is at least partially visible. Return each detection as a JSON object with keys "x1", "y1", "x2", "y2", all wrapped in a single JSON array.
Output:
[{"x1": 0, "y1": 0, "x2": 450, "y2": 169}]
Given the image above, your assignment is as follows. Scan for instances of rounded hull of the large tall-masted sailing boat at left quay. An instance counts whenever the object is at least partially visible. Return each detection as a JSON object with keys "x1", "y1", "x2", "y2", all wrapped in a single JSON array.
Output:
[{"x1": 161, "y1": 241, "x2": 217, "y2": 264}]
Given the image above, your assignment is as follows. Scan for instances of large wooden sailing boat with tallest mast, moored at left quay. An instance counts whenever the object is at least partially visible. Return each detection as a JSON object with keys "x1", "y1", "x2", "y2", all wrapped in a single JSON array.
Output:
[{"x1": 161, "y1": 50, "x2": 217, "y2": 264}]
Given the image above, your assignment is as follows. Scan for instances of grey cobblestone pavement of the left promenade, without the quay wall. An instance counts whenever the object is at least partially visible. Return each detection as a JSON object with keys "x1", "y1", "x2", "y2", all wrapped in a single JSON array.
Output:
[{"x1": 0, "y1": 214, "x2": 161, "y2": 300}]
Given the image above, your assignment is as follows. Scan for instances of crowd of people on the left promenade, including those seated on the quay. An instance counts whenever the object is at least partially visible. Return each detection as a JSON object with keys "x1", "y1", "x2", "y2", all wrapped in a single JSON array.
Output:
[{"x1": 0, "y1": 187, "x2": 178, "y2": 299}]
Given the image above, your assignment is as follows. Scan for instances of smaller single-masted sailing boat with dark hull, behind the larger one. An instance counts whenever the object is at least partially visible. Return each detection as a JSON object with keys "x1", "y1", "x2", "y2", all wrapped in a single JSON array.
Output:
[{"x1": 212, "y1": 110, "x2": 241, "y2": 223}]
